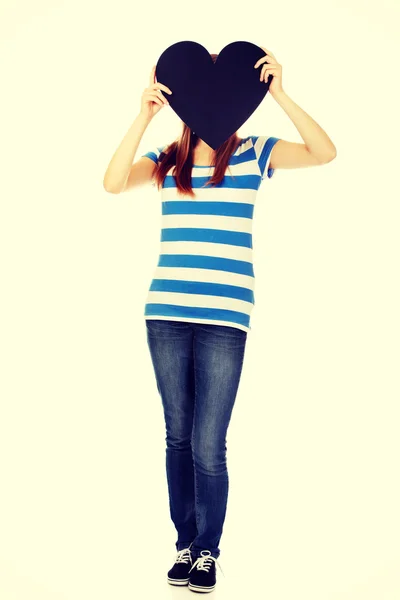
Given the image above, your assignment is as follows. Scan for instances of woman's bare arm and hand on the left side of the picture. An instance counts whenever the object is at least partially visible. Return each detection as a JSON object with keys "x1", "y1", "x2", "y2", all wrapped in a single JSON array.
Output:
[{"x1": 103, "y1": 67, "x2": 171, "y2": 194}]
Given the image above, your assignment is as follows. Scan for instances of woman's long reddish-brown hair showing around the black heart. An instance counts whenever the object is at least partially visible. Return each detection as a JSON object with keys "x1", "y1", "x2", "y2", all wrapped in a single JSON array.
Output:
[{"x1": 153, "y1": 54, "x2": 241, "y2": 197}]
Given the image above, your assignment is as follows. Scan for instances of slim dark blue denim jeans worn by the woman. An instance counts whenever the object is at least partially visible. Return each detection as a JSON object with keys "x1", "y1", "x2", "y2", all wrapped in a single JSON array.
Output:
[{"x1": 145, "y1": 319, "x2": 247, "y2": 558}]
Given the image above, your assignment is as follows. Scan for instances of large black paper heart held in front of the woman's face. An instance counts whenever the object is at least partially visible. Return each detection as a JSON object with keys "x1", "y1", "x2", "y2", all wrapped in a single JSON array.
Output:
[{"x1": 156, "y1": 41, "x2": 272, "y2": 150}]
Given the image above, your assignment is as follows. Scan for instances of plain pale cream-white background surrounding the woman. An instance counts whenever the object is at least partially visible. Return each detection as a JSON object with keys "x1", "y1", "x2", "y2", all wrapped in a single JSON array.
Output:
[{"x1": 0, "y1": 0, "x2": 400, "y2": 600}]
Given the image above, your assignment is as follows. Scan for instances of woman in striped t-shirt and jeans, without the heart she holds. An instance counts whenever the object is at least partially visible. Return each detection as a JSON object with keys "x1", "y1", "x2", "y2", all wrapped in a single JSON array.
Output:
[{"x1": 104, "y1": 48, "x2": 336, "y2": 592}]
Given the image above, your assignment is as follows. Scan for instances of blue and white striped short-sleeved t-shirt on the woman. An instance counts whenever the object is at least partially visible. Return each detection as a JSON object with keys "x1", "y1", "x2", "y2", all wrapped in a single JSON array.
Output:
[{"x1": 142, "y1": 136, "x2": 280, "y2": 332}]
